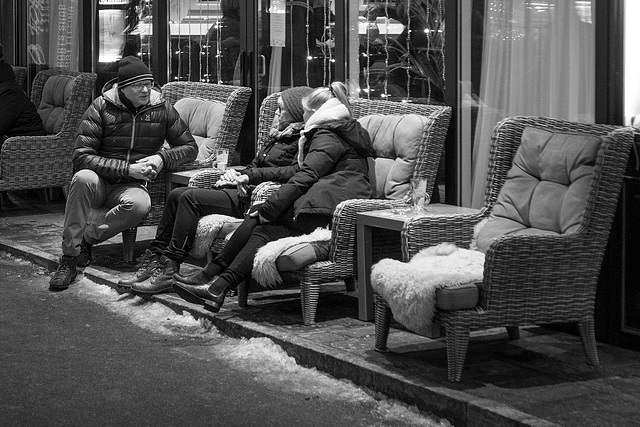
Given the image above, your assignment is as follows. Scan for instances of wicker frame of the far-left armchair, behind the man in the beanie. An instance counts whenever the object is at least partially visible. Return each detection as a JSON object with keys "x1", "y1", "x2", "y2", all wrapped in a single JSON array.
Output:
[{"x1": 0, "y1": 69, "x2": 96, "y2": 191}]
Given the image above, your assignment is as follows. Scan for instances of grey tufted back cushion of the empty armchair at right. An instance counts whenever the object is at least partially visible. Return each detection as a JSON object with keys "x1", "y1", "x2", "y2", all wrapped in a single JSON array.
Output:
[{"x1": 476, "y1": 128, "x2": 601, "y2": 252}]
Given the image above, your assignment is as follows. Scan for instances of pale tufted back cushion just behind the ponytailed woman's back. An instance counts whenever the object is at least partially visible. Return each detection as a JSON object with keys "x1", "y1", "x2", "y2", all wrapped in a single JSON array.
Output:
[{"x1": 358, "y1": 114, "x2": 430, "y2": 199}]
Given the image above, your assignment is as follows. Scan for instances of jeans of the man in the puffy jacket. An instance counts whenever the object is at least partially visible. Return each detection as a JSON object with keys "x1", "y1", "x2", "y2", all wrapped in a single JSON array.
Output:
[{"x1": 62, "y1": 169, "x2": 151, "y2": 256}]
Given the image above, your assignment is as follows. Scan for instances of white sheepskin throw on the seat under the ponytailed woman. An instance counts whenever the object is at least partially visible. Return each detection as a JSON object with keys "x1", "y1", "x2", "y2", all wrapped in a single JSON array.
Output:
[{"x1": 251, "y1": 228, "x2": 331, "y2": 289}]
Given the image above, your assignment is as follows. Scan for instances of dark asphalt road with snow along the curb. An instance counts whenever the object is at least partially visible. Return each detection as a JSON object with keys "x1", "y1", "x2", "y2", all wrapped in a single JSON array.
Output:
[{"x1": 0, "y1": 252, "x2": 439, "y2": 426}]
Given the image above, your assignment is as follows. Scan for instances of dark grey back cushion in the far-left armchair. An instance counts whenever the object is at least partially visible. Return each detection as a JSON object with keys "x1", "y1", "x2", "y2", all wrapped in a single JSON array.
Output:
[{"x1": 38, "y1": 74, "x2": 76, "y2": 135}]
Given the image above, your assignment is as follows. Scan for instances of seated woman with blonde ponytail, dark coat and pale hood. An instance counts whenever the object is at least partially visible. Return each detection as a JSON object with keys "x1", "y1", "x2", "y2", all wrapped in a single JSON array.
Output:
[{"x1": 173, "y1": 82, "x2": 374, "y2": 312}]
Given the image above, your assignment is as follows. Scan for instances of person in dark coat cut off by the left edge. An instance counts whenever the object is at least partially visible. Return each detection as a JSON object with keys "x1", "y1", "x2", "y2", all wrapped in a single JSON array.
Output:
[{"x1": 0, "y1": 45, "x2": 46, "y2": 147}]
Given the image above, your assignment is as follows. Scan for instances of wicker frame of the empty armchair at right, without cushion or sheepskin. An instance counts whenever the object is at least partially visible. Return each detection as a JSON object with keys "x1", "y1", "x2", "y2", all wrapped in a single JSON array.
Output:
[{"x1": 375, "y1": 117, "x2": 633, "y2": 381}]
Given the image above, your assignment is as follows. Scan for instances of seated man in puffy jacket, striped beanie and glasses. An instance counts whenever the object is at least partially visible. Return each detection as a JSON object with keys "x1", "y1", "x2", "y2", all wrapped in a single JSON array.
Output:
[{"x1": 49, "y1": 56, "x2": 198, "y2": 290}]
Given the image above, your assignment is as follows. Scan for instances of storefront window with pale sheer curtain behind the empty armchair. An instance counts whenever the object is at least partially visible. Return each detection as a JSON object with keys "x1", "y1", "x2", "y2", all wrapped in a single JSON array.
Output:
[{"x1": 458, "y1": 0, "x2": 595, "y2": 207}]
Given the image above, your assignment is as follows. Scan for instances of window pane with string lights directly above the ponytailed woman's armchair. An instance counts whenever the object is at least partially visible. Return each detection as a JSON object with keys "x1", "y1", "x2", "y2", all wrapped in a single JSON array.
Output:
[{"x1": 348, "y1": 0, "x2": 445, "y2": 104}]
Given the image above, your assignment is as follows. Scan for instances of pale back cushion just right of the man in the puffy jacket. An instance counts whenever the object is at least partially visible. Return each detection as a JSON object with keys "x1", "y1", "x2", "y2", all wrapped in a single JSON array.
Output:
[{"x1": 174, "y1": 98, "x2": 226, "y2": 160}]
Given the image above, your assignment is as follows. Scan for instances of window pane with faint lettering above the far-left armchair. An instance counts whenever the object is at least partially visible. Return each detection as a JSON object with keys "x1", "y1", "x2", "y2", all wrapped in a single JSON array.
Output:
[{"x1": 27, "y1": 0, "x2": 80, "y2": 75}]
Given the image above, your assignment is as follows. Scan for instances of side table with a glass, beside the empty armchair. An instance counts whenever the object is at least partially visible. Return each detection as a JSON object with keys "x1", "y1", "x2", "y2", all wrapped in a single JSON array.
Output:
[{"x1": 356, "y1": 203, "x2": 478, "y2": 321}]
